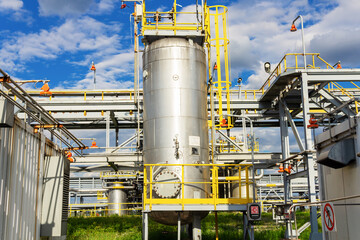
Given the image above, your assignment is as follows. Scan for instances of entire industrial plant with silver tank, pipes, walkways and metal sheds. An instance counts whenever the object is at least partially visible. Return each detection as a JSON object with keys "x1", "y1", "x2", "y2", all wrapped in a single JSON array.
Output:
[{"x1": 0, "y1": 0, "x2": 360, "y2": 240}]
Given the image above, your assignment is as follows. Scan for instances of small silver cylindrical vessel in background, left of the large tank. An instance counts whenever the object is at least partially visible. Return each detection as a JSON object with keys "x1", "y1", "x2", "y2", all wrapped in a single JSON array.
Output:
[{"x1": 108, "y1": 183, "x2": 127, "y2": 216}]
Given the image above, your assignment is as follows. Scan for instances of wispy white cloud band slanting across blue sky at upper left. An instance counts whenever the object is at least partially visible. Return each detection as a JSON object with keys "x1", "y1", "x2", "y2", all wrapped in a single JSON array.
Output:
[{"x1": 0, "y1": 17, "x2": 120, "y2": 71}]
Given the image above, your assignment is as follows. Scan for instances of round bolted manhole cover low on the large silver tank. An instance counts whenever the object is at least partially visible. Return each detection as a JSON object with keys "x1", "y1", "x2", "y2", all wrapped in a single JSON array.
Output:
[{"x1": 153, "y1": 170, "x2": 181, "y2": 198}]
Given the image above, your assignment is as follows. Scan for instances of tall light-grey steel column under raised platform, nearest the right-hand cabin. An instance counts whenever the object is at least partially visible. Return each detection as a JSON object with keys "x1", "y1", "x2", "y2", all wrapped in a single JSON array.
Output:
[{"x1": 301, "y1": 72, "x2": 322, "y2": 240}]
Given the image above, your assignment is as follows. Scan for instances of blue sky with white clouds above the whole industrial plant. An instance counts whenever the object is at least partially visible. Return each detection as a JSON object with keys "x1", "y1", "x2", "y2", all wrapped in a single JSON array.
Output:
[{"x1": 0, "y1": 0, "x2": 360, "y2": 89}]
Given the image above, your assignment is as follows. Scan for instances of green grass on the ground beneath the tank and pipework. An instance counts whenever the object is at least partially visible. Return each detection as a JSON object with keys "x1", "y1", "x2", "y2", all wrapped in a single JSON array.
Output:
[{"x1": 67, "y1": 212, "x2": 321, "y2": 240}]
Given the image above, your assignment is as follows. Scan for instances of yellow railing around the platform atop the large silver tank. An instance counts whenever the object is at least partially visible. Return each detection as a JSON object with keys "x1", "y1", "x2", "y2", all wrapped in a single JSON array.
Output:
[{"x1": 141, "y1": 0, "x2": 203, "y2": 35}]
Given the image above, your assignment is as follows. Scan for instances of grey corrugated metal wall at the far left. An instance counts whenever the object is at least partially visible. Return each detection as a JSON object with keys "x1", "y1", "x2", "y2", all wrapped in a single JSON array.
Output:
[{"x1": 0, "y1": 119, "x2": 53, "y2": 240}]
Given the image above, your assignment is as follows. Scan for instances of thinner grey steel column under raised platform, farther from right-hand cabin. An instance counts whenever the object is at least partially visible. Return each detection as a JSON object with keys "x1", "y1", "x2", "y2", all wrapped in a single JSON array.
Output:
[{"x1": 279, "y1": 101, "x2": 292, "y2": 239}]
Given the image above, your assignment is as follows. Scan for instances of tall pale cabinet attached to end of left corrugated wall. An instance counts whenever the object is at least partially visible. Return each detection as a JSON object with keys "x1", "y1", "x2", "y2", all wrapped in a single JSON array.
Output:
[{"x1": 40, "y1": 155, "x2": 70, "y2": 240}]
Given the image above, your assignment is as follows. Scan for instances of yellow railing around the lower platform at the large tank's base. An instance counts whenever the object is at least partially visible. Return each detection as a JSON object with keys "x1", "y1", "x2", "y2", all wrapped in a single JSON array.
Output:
[{"x1": 143, "y1": 164, "x2": 252, "y2": 210}]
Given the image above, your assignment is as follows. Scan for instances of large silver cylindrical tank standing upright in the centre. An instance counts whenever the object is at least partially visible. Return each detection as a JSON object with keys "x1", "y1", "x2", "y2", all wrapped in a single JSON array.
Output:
[{"x1": 143, "y1": 37, "x2": 210, "y2": 224}]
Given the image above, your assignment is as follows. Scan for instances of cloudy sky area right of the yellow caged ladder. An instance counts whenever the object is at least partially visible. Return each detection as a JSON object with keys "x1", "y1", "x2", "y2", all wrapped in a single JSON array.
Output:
[{"x1": 228, "y1": 0, "x2": 360, "y2": 89}]
